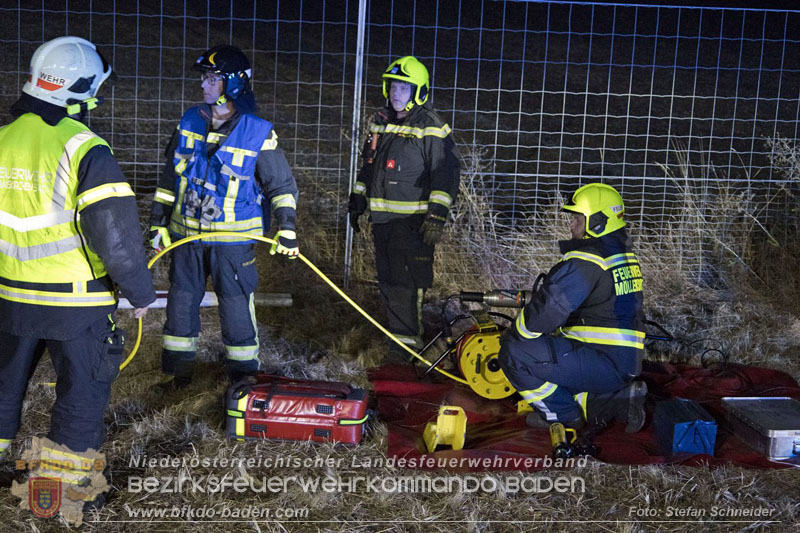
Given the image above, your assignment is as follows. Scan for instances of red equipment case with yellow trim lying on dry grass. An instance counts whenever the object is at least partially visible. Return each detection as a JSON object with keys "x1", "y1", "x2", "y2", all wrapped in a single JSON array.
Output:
[{"x1": 225, "y1": 374, "x2": 369, "y2": 444}]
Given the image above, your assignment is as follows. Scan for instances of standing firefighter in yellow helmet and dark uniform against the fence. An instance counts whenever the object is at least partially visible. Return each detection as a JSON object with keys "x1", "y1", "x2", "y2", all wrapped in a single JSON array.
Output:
[{"x1": 348, "y1": 56, "x2": 461, "y2": 362}]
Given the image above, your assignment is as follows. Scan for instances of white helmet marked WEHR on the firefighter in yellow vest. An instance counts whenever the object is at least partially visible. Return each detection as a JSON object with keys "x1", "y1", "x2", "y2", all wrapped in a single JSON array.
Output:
[{"x1": 22, "y1": 36, "x2": 111, "y2": 107}]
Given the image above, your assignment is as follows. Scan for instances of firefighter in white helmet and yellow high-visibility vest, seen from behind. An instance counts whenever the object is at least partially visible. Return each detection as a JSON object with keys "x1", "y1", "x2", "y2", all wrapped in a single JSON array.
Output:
[{"x1": 0, "y1": 37, "x2": 156, "y2": 508}]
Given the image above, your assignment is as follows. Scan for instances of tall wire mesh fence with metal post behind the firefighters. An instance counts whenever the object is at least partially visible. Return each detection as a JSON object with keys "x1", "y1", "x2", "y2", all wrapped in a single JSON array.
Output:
[{"x1": 0, "y1": 0, "x2": 800, "y2": 288}]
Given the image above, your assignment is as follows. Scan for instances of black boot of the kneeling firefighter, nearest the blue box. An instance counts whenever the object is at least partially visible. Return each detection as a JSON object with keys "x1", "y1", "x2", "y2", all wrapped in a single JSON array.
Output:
[{"x1": 586, "y1": 381, "x2": 647, "y2": 433}]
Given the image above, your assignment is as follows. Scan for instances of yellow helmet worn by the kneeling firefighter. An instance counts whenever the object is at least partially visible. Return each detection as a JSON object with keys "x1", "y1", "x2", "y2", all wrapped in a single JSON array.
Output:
[{"x1": 562, "y1": 183, "x2": 625, "y2": 238}]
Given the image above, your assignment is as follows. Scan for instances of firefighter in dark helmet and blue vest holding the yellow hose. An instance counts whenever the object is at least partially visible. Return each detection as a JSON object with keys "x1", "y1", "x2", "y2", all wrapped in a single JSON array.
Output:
[{"x1": 150, "y1": 45, "x2": 299, "y2": 388}]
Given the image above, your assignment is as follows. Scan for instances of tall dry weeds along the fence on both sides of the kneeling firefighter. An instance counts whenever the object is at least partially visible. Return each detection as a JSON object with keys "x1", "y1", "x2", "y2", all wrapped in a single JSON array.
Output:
[{"x1": 434, "y1": 141, "x2": 800, "y2": 378}]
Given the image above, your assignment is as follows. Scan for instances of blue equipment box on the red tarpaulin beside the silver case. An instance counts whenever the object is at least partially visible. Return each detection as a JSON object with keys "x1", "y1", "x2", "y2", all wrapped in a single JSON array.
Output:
[{"x1": 653, "y1": 398, "x2": 717, "y2": 456}]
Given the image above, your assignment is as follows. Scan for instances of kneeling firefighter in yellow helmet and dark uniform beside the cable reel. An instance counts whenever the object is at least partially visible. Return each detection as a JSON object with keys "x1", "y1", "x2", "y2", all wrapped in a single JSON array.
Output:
[{"x1": 498, "y1": 183, "x2": 647, "y2": 433}]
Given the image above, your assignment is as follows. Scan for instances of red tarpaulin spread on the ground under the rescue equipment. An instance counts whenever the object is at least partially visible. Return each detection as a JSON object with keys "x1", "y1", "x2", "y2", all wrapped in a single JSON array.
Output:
[{"x1": 369, "y1": 362, "x2": 800, "y2": 471}]
